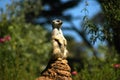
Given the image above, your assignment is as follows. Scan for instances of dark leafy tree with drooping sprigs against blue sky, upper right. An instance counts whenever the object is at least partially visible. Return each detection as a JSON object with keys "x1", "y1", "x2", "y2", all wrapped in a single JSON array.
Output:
[{"x1": 82, "y1": 0, "x2": 120, "y2": 47}]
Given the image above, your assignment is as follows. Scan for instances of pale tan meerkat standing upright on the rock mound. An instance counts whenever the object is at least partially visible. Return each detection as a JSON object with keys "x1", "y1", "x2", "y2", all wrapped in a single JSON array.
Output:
[{"x1": 52, "y1": 19, "x2": 68, "y2": 59}]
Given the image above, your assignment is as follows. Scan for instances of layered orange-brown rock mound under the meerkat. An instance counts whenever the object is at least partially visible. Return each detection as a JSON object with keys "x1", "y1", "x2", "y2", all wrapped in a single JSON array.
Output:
[{"x1": 36, "y1": 59, "x2": 72, "y2": 80}]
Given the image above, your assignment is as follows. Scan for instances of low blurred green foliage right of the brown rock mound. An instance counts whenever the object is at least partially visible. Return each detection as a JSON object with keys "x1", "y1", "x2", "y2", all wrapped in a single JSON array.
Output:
[{"x1": 73, "y1": 55, "x2": 120, "y2": 80}]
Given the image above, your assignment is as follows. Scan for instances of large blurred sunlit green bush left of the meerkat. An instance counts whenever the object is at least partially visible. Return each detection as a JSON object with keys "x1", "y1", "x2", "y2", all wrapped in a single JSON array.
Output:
[{"x1": 0, "y1": 1, "x2": 51, "y2": 80}]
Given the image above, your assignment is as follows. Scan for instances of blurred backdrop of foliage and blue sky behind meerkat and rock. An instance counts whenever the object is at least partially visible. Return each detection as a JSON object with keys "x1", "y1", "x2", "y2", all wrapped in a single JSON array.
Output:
[{"x1": 0, "y1": 0, "x2": 120, "y2": 80}]
